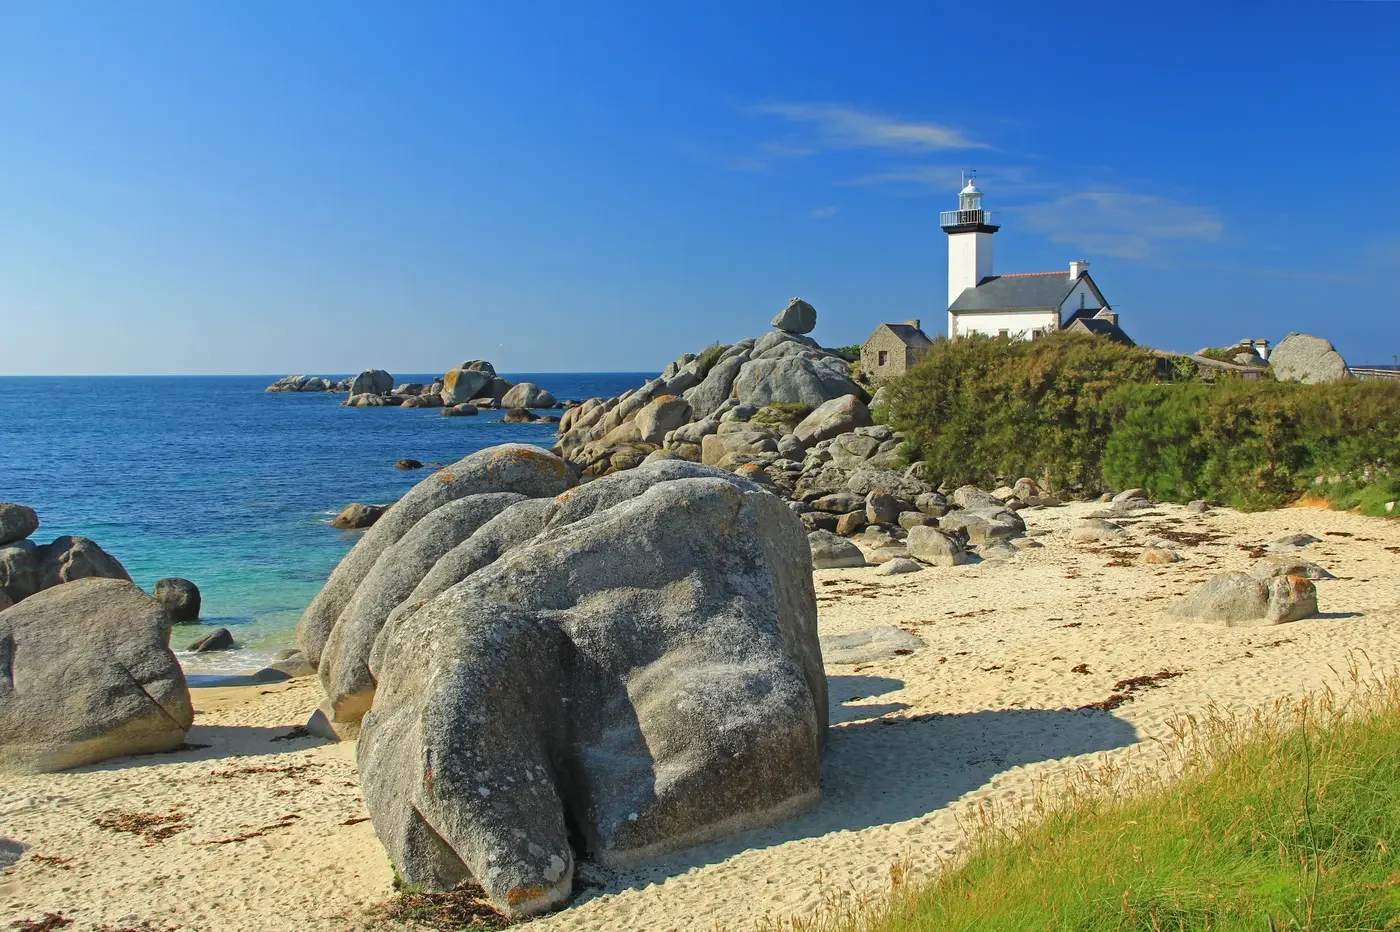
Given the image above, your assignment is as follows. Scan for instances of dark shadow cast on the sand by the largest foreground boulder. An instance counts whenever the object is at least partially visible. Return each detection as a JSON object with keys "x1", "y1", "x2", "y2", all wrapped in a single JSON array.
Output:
[{"x1": 575, "y1": 696, "x2": 1138, "y2": 903}]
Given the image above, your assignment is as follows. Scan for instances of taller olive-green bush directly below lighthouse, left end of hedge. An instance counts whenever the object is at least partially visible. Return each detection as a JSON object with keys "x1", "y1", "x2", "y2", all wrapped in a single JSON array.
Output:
[{"x1": 888, "y1": 332, "x2": 1158, "y2": 491}]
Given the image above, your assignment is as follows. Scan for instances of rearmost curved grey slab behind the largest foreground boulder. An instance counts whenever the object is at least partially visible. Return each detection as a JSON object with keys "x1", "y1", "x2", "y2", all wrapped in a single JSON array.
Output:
[{"x1": 297, "y1": 442, "x2": 574, "y2": 688}]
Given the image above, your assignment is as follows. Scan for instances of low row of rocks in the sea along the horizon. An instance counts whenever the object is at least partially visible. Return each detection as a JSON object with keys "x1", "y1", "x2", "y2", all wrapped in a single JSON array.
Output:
[{"x1": 266, "y1": 360, "x2": 564, "y2": 423}]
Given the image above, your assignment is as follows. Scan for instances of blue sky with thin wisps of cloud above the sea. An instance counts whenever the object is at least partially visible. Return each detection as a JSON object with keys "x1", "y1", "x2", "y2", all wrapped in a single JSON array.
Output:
[{"x1": 0, "y1": 0, "x2": 1400, "y2": 374}]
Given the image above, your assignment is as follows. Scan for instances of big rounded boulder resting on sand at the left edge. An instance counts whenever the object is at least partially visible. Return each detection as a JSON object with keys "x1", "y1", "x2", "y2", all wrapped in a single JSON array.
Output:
[{"x1": 0, "y1": 579, "x2": 195, "y2": 772}]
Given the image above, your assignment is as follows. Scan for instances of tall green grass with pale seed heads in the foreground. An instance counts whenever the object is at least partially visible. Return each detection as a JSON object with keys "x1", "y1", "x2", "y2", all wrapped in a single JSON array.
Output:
[{"x1": 791, "y1": 670, "x2": 1400, "y2": 932}]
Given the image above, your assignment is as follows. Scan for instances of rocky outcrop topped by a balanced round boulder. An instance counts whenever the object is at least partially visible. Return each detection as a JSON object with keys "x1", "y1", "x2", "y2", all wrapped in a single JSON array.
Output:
[{"x1": 554, "y1": 298, "x2": 869, "y2": 479}]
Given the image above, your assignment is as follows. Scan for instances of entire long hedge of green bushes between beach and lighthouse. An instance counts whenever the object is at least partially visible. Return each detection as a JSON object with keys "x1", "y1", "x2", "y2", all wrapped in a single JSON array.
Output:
[{"x1": 888, "y1": 333, "x2": 1400, "y2": 514}]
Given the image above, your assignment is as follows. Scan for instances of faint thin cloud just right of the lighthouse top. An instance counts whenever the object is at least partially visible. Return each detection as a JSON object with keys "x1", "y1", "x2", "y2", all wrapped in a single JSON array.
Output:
[{"x1": 1018, "y1": 190, "x2": 1224, "y2": 259}]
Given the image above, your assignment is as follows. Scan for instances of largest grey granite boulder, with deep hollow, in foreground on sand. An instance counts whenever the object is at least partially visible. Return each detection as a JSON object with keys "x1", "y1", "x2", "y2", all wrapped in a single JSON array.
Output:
[{"x1": 357, "y1": 460, "x2": 827, "y2": 917}]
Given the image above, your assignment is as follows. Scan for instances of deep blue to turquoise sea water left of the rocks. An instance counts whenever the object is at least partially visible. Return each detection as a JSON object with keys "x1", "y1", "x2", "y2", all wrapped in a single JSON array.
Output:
[{"x1": 0, "y1": 372, "x2": 654, "y2": 673}]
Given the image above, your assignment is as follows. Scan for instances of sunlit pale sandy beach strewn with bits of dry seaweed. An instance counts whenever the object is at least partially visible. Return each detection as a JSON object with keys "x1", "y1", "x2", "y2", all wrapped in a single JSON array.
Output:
[{"x1": 0, "y1": 505, "x2": 1400, "y2": 932}]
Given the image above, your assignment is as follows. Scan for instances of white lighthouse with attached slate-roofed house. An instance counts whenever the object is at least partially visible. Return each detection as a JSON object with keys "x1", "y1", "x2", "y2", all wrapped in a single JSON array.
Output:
[{"x1": 939, "y1": 181, "x2": 1133, "y2": 344}]
